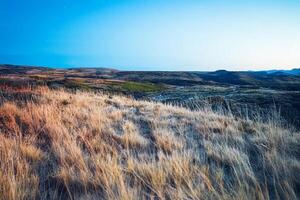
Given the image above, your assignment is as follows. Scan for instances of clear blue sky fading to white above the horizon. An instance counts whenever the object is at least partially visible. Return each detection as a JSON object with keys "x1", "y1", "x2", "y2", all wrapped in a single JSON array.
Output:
[{"x1": 0, "y1": 0, "x2": 300, "y2": 71}]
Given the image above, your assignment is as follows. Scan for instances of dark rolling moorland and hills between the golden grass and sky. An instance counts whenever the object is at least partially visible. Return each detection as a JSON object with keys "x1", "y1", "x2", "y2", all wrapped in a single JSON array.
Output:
[{"x1": 0, "y1": 65, "x2": 300, "y2": 127}]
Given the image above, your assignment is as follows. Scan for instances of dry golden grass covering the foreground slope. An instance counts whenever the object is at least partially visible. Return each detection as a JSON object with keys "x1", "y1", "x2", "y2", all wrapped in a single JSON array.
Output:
[{"x1": 0, "y1": 88, "x2": 300, "y2": 200}]
